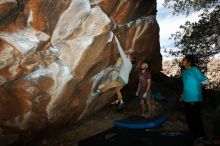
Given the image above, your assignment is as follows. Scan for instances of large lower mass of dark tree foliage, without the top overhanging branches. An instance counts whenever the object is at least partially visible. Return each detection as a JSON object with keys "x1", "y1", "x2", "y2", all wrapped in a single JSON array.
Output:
[{"x1": 169, "y1": 6, "x2": 220, "y2": 71}]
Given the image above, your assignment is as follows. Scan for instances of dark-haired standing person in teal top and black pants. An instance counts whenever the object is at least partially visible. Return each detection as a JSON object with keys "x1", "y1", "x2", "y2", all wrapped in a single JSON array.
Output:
[{"x1": 181, "y1": 55, "x2": 208, "y2": 137}]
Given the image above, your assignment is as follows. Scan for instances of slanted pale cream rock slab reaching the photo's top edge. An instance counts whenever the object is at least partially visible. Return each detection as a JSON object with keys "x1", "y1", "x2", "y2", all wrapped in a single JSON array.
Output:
[{"x1": 51, "y1": 0, "x2": 91, "y2": 45}]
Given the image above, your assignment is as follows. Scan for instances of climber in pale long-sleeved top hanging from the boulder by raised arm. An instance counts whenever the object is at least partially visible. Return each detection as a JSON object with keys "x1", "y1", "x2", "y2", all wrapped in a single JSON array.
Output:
[{"x1": 97, "y1": 36, "x2": 134, "y2": 111}]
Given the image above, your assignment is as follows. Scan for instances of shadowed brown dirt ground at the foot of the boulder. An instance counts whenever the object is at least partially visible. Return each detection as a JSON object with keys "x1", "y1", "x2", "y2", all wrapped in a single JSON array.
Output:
[{"x1": 35, "y1": 98, "x2": 192, "y2": 146}]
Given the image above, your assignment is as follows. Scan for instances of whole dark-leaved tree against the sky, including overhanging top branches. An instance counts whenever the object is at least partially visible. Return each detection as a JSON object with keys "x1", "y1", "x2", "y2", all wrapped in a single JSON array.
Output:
[{"x1": 165, "y1": 0, "x2": 220, "y2": 71}]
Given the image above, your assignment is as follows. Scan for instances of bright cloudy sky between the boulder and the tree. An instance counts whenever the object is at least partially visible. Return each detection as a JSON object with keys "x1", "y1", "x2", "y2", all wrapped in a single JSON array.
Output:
[{"x1": 157, "y1": 0, "x2": 201, "y2": 60}]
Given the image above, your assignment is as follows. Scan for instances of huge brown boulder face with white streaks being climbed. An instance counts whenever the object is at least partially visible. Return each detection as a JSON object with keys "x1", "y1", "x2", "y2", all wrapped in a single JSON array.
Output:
[{"x1": 0, "y1": 0, "x2": 161, "y2": 130}]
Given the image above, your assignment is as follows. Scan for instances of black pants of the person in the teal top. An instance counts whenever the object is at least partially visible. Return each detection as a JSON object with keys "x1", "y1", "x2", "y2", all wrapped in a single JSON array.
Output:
[{"x1": 184, "y1": 102, "x2": 205, "y2": 137}]
